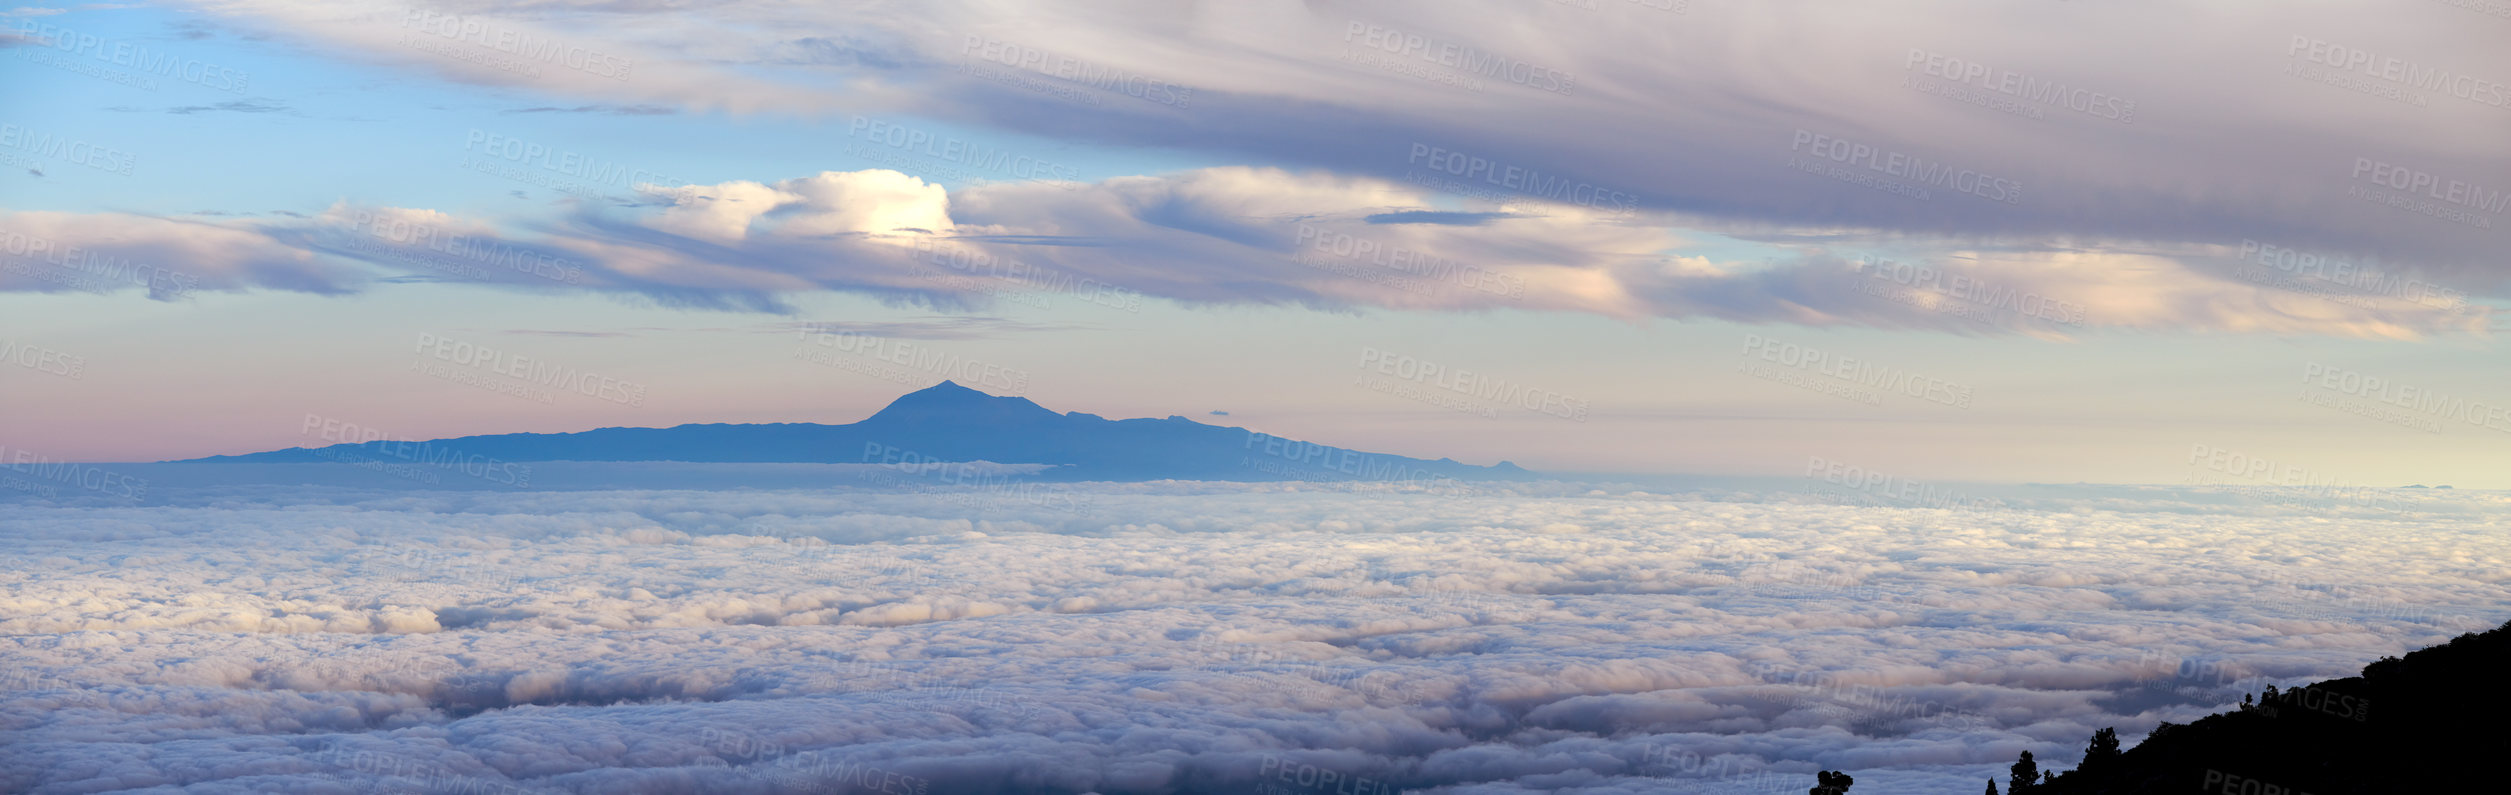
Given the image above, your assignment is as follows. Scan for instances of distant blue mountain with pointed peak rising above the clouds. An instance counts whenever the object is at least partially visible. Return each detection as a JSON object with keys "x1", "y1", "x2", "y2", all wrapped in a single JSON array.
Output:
[{"x1": 173, "y1": 381, "x2": 1532, "y2": 482}]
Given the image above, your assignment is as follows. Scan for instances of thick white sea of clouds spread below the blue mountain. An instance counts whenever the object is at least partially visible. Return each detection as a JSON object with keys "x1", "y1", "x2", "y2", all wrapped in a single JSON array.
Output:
[{"x1": 0, "y1": 473, "x2": 2511, "y2": 795}]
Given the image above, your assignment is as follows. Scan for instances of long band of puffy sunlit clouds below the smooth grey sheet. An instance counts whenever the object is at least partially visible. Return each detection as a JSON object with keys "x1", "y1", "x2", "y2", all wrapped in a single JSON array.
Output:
[{"x1": 15, "y1": 166, "x2": 2491, "y2": 339}]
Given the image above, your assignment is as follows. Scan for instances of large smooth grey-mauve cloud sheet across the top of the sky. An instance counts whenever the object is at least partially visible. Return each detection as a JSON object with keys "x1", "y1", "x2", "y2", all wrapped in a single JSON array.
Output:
[{"x1": 185, "y1": 0, "x2": 2511, "y2": 293}]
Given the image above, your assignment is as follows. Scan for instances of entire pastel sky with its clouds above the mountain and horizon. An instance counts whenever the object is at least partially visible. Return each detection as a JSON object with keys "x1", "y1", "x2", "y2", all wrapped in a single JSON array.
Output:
[{"x1": 0, "y1": 0, "x2": 2511, "y2": 489}]
